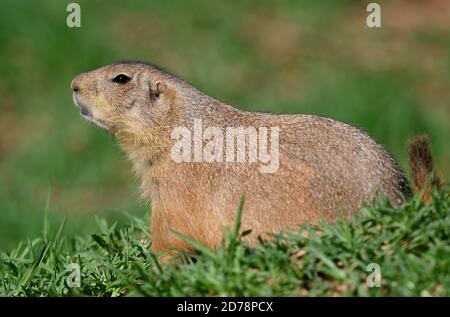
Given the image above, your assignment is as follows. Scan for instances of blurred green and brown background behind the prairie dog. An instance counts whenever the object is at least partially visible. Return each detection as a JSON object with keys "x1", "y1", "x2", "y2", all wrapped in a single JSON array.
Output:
[{"x1": 0, "y1": 0, "x2": 450, "y2": 251}]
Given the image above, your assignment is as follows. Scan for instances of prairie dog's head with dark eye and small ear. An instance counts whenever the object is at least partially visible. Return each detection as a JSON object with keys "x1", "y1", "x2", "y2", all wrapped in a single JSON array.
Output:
[{"x1": 71, "y1": 62, "x2": 176, "y2": 138}]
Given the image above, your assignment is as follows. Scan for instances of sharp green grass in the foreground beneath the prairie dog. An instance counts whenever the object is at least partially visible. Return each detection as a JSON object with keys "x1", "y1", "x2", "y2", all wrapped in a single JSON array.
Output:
[{"x1": 0, "y1": 186, "x2": 450, "y2": 296}]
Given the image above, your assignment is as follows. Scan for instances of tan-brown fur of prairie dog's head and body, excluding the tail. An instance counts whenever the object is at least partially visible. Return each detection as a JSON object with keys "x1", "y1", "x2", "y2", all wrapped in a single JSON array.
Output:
[{"x1": 72, "y1": 62, "x2": 410, "y2": 252}]
